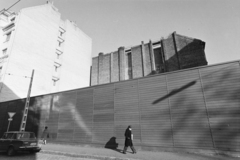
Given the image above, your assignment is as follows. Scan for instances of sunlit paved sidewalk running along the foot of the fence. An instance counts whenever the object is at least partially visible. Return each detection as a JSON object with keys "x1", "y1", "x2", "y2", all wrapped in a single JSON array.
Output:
[{"x1": 41, "y1": 143, "x2": 239, "y2": 160}]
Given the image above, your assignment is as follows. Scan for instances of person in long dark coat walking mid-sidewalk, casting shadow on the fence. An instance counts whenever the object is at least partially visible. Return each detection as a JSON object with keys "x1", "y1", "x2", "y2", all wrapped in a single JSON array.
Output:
[{"x1": 123, "y1": 126, "x2": 137, "y2": 154}]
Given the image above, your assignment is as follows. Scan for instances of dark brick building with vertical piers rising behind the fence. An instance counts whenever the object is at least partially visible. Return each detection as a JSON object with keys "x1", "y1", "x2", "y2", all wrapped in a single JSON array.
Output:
[{"x1": 90, "y1": 32, "x2": 207, "y2": 86}]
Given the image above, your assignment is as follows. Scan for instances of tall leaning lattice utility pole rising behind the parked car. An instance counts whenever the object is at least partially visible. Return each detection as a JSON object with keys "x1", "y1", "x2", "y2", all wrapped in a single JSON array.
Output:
[{"x1": 20, "y1": 70, "x2": 34, "y2": 131}]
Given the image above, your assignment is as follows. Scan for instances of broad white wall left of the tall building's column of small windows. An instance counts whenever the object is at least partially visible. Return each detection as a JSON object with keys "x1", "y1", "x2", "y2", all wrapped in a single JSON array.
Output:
[{"x1": 1, "y1": 5, "x2": 60, "y2": 101}]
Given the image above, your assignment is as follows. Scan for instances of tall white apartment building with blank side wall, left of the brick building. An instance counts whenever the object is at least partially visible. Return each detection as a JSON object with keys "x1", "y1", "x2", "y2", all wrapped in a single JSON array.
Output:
[{"x1": 0, "y1": 2, "x2": 92, "y2": 102}]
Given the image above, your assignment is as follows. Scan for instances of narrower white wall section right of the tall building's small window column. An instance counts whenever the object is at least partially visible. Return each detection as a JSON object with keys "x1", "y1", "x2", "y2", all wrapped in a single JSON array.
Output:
[{"x1": 59, "y1": 20, "x2": 92, "y2": 91}]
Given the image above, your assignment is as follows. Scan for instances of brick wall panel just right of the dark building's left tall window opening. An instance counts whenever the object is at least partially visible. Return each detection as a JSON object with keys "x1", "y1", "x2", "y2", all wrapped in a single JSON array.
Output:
[{"x1": 131, "y1": 46, "x2": 143, "y2": 78}]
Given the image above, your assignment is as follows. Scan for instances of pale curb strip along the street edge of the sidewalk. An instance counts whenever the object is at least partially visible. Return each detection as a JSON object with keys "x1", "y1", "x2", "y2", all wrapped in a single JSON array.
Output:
[{"x1": 40, "y1": 150, "x2": 139, "y2": 160}]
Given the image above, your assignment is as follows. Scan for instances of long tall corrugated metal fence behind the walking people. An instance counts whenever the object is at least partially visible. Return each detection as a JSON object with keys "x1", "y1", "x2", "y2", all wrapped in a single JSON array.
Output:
[{"x1": 0, "y1": 61, "x2": 240, "y2": 151}]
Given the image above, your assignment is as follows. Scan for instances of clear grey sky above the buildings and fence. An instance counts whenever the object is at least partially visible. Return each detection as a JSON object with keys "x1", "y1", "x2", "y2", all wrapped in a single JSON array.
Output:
[{"x1": 0, "y1": 0, "x2": 240, "y2": 65}]
